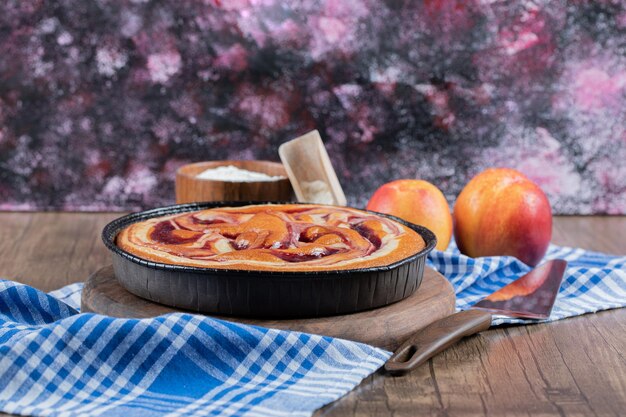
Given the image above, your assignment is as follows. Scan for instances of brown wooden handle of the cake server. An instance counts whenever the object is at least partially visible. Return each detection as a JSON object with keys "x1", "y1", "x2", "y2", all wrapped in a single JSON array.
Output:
[{"x1": 385, "y1": 310, "x2": 491, "y2": 375}]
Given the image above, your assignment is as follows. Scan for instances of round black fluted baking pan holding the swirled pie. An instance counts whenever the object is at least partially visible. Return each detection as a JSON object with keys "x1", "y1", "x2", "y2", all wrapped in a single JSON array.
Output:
[{"x1": 102, "y1": 201, "x2": 437, "y2": 319}]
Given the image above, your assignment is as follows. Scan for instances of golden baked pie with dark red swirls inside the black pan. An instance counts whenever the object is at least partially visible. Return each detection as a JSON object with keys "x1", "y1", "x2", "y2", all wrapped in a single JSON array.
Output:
[{"x1": 116, "y1": 204, "x2": 426, "y2": 272}]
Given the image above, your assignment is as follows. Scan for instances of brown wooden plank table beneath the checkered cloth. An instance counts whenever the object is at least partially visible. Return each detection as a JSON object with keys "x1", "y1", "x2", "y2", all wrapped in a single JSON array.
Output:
[{"x1": 0, "y1": 213, "x2": 626, "y2": 417}]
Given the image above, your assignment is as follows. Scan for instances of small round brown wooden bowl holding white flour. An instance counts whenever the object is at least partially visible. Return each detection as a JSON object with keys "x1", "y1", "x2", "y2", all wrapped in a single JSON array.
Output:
[{"x1": 176, "y1": 161, "x2": 293, "y2": 204}]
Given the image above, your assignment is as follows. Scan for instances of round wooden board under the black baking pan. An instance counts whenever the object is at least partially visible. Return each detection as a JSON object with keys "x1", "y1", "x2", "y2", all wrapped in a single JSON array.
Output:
[{"x1": 81, "y1": 266, "x2": 455, "y2": 350}]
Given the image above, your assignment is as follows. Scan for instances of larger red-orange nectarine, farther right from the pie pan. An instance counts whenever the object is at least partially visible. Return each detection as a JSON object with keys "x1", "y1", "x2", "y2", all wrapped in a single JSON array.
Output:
[{"x1": 454, "y1": 168, "x2": 552, "y2": 266}]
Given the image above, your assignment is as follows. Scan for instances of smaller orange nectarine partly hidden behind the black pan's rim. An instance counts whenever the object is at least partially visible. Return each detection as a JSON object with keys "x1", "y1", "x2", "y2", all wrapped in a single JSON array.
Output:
[{"x1": 367, "y1": 179, "x2": 452, "y2": 250}]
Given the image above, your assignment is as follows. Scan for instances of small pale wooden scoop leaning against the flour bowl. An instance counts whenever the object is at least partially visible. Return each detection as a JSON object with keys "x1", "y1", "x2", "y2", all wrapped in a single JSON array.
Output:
[{"x1": 278, "y1": 130, "x2": 347, "y2": 206}]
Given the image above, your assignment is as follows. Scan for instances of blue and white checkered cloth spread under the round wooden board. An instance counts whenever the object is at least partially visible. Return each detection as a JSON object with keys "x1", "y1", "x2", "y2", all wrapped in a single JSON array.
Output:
[{"x1": 0, "y1": 242, "x2": 626, "y2": 417}]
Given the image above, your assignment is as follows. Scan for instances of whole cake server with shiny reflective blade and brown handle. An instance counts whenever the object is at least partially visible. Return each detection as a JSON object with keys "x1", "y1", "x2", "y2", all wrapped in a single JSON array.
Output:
[{"x1": 385, "y1": 259, "x2": 567, "y2": 375}]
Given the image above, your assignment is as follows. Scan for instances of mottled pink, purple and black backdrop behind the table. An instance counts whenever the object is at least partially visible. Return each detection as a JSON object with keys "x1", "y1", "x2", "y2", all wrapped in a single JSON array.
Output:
[{"x1": 0, "y1": 0, "x2": 626, "y2": 214}]
